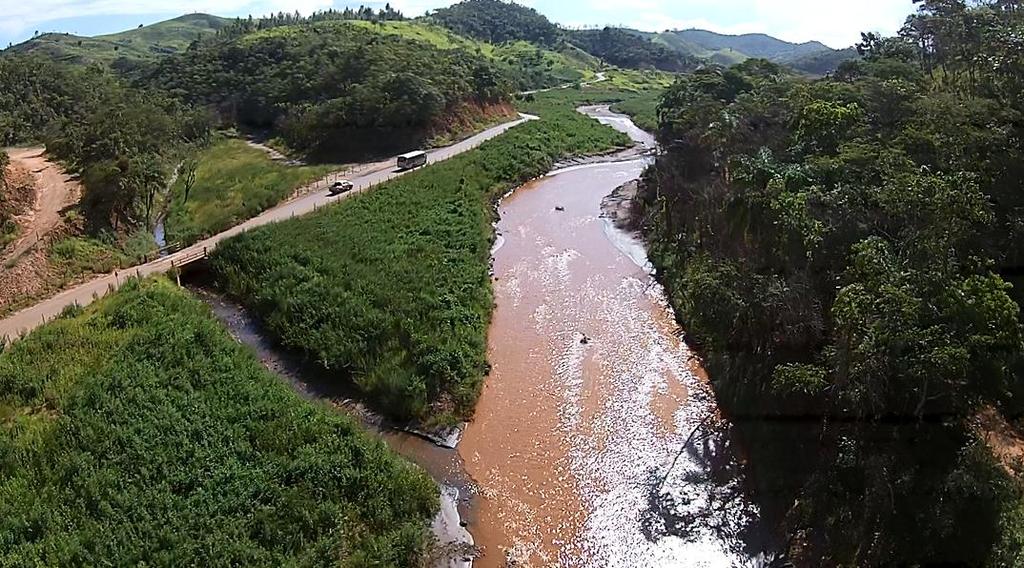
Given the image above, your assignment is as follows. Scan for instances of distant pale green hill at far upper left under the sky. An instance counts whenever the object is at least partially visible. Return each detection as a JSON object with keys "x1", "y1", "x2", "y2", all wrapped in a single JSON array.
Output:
[{"x1": 9, "y1": 13, "x2": 231, "y2": 63}]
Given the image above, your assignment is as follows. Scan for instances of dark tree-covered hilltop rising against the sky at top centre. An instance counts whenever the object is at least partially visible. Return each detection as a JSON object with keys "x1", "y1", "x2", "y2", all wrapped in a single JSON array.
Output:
[{"x1": 430, "y1": 0, "x2": 562, "y2": 47}]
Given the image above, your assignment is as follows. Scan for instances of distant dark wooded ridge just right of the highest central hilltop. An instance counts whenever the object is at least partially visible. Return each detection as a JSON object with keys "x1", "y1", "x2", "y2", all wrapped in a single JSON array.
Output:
[{"x1": 568, "y1": 28, "x2": 699, "y2": 72}]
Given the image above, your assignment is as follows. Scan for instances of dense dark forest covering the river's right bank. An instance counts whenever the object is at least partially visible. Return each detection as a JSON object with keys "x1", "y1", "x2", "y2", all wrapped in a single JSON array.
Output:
[{"x1": 645, "y1": 0, "x2": 1024, "y2": 565}]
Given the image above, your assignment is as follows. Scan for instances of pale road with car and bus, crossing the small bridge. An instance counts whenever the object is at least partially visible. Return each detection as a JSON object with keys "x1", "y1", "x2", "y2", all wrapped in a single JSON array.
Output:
[{"x1": 0, "y1": 115, "x2": 538, "y2": 342}]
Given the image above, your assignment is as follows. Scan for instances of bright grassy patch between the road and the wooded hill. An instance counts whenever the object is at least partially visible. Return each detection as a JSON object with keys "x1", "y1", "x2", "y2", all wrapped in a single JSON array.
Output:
[{"x1": 166, "y1": 138, "x2": 337, "y2": 244}]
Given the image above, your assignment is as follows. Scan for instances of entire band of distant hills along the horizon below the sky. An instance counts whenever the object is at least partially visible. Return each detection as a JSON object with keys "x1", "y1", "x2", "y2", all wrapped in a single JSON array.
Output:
[{"x1": 6, "y1": 0, "x2": 857, "y2": 77}]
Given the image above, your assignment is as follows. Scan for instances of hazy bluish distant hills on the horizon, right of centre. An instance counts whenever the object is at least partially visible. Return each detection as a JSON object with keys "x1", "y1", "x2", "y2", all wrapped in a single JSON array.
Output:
[{"x1": 647, "y1": 30, "x2": 857, "y2": 75}]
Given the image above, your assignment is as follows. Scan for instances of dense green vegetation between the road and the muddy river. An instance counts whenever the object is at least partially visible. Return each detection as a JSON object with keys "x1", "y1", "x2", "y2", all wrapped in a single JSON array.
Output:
[{"x1": 207, "y1": 93, "x2": 628, "y2": 423}]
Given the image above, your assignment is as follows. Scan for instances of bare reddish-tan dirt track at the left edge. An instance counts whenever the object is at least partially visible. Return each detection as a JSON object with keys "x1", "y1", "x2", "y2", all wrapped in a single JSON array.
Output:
[{"x1": 3, "y1": 147, "x2": 82, "y2": 261}]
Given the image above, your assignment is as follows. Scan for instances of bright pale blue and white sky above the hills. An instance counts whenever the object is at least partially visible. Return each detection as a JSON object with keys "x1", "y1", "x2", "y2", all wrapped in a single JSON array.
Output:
[{"x1": 0, "y1": 0, "x2": 913, "y2": 48}]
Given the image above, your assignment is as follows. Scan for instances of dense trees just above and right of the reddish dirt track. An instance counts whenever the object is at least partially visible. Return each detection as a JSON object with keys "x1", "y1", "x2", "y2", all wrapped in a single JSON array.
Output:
[{"x1": 0, "y1": 54, "x2": 210, "y2": 231}]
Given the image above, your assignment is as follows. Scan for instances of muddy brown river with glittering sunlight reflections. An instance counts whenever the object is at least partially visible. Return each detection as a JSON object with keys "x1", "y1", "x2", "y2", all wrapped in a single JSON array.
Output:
[{"x1": 459, "y1": 108, "x2": 763, "y2": 567}]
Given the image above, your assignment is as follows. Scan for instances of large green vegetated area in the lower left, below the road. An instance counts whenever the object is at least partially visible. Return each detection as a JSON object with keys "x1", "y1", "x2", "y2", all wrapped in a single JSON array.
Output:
[{"x1": 0, "y1": 280, "x2": 437, "y2": 566}]
